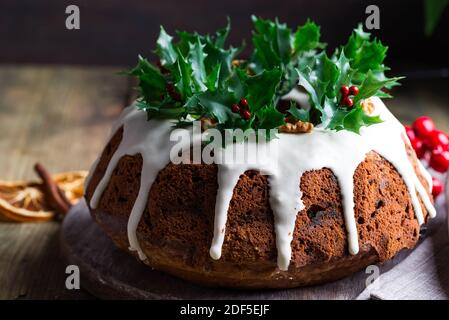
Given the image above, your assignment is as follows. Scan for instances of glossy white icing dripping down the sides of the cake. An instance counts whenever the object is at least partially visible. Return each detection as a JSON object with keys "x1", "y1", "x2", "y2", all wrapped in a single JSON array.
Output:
[{"x1": 86, "y1": 96, "x2": 436, "y2": 270}]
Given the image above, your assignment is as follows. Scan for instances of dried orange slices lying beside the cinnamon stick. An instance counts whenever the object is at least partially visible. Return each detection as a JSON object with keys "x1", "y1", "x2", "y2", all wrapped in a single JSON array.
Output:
[{"x1": 0, "y1": 171, "x2": 87, "y2": 222}]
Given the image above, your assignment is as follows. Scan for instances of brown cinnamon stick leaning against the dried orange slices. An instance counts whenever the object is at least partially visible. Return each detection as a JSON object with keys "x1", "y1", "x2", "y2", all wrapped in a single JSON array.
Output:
[{"x1": 34, "y1": 163, "x2": 72, "y2": 215}]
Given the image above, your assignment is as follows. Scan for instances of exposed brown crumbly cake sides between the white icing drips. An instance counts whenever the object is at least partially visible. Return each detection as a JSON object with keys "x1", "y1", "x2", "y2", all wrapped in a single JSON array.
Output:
[{"x1": 86, "y1": 129, "x2": 429, "y2": 288}]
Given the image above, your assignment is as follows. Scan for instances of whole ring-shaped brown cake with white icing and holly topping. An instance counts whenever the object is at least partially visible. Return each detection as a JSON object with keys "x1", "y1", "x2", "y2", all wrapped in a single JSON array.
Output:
[{"x1": 85, "y1": 18, "x2": 435, "y2": 288}]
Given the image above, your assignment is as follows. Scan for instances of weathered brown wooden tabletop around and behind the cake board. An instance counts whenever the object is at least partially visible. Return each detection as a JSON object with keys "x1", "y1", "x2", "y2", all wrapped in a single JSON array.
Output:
[{"x1": 0, "y1": 66, "x2": 449, "y2": 299}]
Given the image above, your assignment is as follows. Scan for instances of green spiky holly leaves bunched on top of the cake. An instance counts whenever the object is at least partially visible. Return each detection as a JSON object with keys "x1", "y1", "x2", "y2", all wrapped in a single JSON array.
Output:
[{"x1": 128, "y1": 16, "x2": 400, "y2": 139}]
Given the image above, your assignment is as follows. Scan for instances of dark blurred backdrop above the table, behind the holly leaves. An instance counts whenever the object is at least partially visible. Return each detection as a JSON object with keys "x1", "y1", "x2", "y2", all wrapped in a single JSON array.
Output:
[{"x1": 0, "y1": 0, "x2": 449, "y2": 77}]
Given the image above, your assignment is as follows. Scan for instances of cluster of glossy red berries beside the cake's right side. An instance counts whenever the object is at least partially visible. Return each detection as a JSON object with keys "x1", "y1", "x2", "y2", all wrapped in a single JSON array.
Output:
[{"x1": 405, "y1": 116, "x2": 449, "y2": 197}]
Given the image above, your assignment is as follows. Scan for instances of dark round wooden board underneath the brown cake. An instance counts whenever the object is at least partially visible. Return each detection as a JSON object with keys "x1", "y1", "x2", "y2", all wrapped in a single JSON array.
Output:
[{"x1": 61, "y1": 200, "x2": 408, "y2": 300}]
